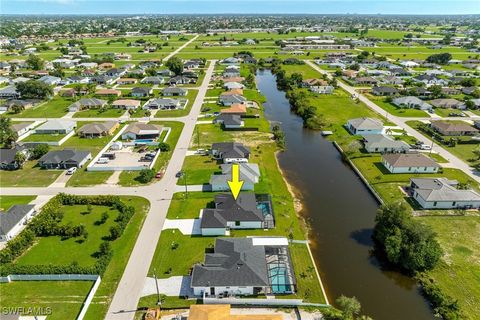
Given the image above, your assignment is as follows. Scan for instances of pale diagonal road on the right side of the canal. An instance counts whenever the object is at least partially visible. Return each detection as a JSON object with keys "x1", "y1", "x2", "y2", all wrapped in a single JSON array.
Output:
[{"x1": 305, "y1": 60, "x2": 480, "y2": 183}]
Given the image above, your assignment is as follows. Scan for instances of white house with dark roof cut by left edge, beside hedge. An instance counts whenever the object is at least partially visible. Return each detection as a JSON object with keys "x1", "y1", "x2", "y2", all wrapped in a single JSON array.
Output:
[{"x1": 0, "y1": 204, "x2": 36, "y2": 242}]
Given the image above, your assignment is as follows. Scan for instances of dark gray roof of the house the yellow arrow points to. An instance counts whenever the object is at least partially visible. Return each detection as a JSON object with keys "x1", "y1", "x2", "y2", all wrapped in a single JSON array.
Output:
[{"x1": 200, "y1": 192, "x2": 265, "y2": 228}]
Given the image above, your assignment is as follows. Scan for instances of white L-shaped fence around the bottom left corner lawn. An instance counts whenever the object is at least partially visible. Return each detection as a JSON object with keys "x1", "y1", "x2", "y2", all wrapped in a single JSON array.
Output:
[{"x1": 0, "y1": 274, "x2": 102, "y2": 320}]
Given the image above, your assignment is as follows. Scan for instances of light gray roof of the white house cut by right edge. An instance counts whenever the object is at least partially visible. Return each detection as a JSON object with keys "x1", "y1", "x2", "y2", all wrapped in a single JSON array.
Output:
[{"x1": 410, "y1": 178, "x2": 480, "y2": 201}]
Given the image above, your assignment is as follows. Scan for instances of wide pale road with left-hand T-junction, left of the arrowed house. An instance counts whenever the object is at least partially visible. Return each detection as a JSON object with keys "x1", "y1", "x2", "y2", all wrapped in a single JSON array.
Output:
[{"x1": 0, "y1": 61, "x2": 216, "y2": 320}]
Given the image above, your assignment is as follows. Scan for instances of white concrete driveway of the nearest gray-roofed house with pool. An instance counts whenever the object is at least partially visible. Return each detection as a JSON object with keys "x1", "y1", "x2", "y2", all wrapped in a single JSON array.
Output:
[{"x1": 141, "y1": 276, "x2": 193, "y2": 297}]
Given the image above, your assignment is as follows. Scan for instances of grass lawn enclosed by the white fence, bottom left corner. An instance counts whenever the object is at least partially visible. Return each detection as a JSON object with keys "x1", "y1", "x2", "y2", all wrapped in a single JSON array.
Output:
[{"x1": 0, "y1": 281, "x2": 93, "y2": 320}]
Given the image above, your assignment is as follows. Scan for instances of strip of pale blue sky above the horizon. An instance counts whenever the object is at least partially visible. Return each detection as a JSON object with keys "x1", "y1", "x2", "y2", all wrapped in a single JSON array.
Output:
[{"x1": 0, "y1": 0, "x2": 480, "y2": 14}]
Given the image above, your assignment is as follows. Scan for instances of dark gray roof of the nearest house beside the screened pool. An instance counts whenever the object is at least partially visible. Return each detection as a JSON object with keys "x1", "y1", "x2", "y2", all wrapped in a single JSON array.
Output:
[{"x1": 191, "y1": 238, "x2": 269, "y2": 287}]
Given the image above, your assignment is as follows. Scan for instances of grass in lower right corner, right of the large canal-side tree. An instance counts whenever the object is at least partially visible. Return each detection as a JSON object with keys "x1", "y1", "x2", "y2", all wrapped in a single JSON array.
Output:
[{"x1": 416, "y1": 216, "x2": 480, "y2": 320}]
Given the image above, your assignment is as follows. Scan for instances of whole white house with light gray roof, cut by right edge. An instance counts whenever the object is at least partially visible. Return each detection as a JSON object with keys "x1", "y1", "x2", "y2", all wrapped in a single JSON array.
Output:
[{"x1": 410, "y1": 178, "x2": 480, "y2": 209}]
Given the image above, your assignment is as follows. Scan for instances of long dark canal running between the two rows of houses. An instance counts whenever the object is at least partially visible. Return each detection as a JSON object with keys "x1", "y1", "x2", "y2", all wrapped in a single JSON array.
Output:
[{"x1": 257, "y1": 70, "x2": 433, "y2": 320}]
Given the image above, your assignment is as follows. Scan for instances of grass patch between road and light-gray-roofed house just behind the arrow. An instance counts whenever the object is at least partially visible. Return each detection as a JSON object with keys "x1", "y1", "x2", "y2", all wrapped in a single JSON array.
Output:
[{"x1": 177, "y1": 155, "x2": 221, "y2": 185}]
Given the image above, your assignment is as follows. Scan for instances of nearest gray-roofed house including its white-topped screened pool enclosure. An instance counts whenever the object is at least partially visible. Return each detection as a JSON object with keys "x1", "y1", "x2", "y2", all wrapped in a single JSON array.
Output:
[{"x1": 190, "y1": 237, "x2": 296, "y2": 296}]
